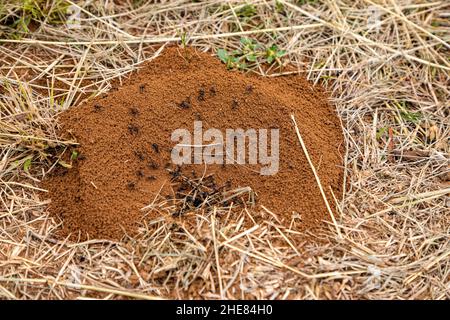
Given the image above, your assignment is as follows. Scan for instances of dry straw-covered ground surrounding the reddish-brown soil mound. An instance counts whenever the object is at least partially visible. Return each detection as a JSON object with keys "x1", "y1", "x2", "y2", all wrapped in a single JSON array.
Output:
[{"x1": 0, "y1": 0, "x2": 450, "y2": 299}]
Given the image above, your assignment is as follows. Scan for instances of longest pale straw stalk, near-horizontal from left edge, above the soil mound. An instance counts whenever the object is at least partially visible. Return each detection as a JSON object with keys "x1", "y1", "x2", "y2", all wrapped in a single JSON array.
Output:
[{"x1": 0, "y1": 23, "x2": 322, "y2": 45}]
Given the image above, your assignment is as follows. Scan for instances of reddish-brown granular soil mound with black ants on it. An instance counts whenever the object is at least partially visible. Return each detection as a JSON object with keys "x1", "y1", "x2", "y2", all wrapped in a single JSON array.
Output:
[{"x1": 43, "y1": 47, "x2": 343, "y2": 239}]
